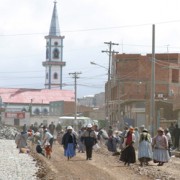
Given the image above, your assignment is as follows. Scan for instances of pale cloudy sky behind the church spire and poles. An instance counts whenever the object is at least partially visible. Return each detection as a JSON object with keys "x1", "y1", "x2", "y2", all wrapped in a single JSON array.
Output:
[{"x1": 0, "y1": 0, "x2": 180, "y2": 97}]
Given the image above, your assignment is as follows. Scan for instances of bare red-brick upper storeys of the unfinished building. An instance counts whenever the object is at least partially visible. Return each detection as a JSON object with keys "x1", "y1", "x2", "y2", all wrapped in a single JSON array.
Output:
[{"x1": 112, "y1": 54, "x2": 180, "y2": 100}]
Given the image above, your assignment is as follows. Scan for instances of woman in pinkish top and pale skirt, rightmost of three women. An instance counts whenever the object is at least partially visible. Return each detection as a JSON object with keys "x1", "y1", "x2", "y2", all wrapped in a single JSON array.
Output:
[{"x1": 152, "y1": 127, "x2": 169, "y2": 166}]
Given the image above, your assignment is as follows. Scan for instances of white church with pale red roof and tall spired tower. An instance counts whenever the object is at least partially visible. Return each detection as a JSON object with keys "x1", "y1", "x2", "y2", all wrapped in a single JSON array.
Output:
[{"x1": 0, "y1": 1, "x2": 75, "y2": 126}]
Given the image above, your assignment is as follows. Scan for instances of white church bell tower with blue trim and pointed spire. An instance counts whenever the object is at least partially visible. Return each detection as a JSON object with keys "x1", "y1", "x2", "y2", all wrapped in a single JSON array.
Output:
[{"x1": 43, "y1": 1, "x2": 65, "y2": 89}]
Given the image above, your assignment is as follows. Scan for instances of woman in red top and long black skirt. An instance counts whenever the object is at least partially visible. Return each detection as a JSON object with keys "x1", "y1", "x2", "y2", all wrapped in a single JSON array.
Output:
[{"x1": 120, "y1": 127, "x2": 136, "y2": 166}]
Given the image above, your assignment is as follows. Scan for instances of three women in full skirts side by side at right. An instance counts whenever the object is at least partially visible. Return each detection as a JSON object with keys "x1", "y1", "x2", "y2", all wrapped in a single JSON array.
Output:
[{"x1": 120, "y1": 127, "x2": 170, "y2": 166}]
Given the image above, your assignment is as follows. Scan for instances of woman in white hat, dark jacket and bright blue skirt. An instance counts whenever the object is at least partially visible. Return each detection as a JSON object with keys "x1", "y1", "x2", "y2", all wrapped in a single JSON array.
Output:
[{"x1": 62, "y1": 126, "x2": 77, "y2": 160}]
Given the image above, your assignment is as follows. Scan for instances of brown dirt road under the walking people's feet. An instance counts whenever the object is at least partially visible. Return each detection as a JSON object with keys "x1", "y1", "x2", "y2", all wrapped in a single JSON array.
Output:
[{"x1": 33, "y1": 144, "x2": 180, "y2": 180}]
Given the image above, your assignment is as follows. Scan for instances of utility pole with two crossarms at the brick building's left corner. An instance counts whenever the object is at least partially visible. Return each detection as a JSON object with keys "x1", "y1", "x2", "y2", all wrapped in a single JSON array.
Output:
[{"x1": 102, "y1": 41, "x2": 119, "y2": 126}]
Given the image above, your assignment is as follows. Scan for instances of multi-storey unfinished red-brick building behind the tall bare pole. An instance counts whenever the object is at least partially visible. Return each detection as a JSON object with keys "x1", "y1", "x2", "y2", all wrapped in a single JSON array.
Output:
[{"x1": 105, "y1": 53, "x2": 180, "y2": 133}]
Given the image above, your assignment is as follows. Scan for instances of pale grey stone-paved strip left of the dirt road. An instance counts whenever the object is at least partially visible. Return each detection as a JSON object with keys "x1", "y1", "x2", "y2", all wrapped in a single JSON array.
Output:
[{"x1": 0, "y1": 139, "x2": 38, "y2": 180}]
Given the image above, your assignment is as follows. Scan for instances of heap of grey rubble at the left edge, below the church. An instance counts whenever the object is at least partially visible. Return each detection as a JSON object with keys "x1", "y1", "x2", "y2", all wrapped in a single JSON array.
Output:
[{"x1": 0, "y1": 124, "x2": 19, "y2": 140}]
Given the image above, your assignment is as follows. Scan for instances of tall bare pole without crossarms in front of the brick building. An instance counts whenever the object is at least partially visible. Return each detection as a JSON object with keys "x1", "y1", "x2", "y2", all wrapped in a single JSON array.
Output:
[{"x1": 150, "y1": 24, "x2": 157, "y2": 136}]
